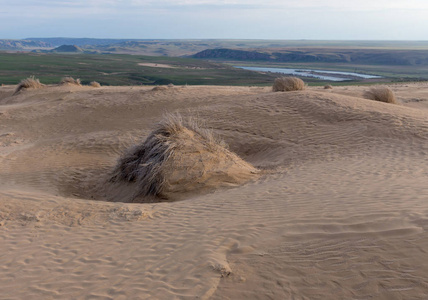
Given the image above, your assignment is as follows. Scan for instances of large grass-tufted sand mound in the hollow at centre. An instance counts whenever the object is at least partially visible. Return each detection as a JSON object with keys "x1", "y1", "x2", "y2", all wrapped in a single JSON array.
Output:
[{"x1": 110, "y1": 115, "x2": 258, "y2": 201}]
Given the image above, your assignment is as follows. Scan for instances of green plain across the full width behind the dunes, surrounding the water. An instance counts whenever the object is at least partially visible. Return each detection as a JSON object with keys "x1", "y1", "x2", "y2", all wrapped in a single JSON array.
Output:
[{"x1": 0, "y1": 52, "x2": 428, "y2": 85}]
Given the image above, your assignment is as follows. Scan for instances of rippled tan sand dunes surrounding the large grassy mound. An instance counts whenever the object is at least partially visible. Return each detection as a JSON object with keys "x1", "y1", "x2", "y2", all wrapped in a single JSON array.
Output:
[{"x1": 0, "y1": 83, "x2": 428, "y2": 299}]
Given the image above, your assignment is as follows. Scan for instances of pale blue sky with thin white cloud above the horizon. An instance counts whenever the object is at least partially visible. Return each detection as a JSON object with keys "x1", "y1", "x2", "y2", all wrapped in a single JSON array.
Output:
[{"x1": 0, "y1": 0, "x2": 428, "y2": 40}]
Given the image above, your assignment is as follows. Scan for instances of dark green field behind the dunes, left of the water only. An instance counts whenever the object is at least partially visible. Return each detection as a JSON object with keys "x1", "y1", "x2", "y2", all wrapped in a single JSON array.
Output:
[{"x1": 0, "y1": 53, "x2": 277, "y2": 85}]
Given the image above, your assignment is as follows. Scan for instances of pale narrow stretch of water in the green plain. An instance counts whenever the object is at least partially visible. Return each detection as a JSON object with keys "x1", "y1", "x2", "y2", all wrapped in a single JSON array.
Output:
[{"x1": 234, "y1": 66, "x2": 382, "y2": 81}]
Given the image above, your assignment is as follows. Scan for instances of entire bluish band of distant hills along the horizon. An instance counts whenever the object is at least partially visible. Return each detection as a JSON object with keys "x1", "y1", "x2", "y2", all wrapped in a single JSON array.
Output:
[{"x1": 5, "y1": 37, "x2": 428, "y2": 66}]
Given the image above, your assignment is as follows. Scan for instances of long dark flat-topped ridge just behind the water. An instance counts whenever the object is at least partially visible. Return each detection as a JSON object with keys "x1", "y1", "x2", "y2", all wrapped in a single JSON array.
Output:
[{"x1": 195, "y1": 48, "x2": 428, "y2": 66}]
